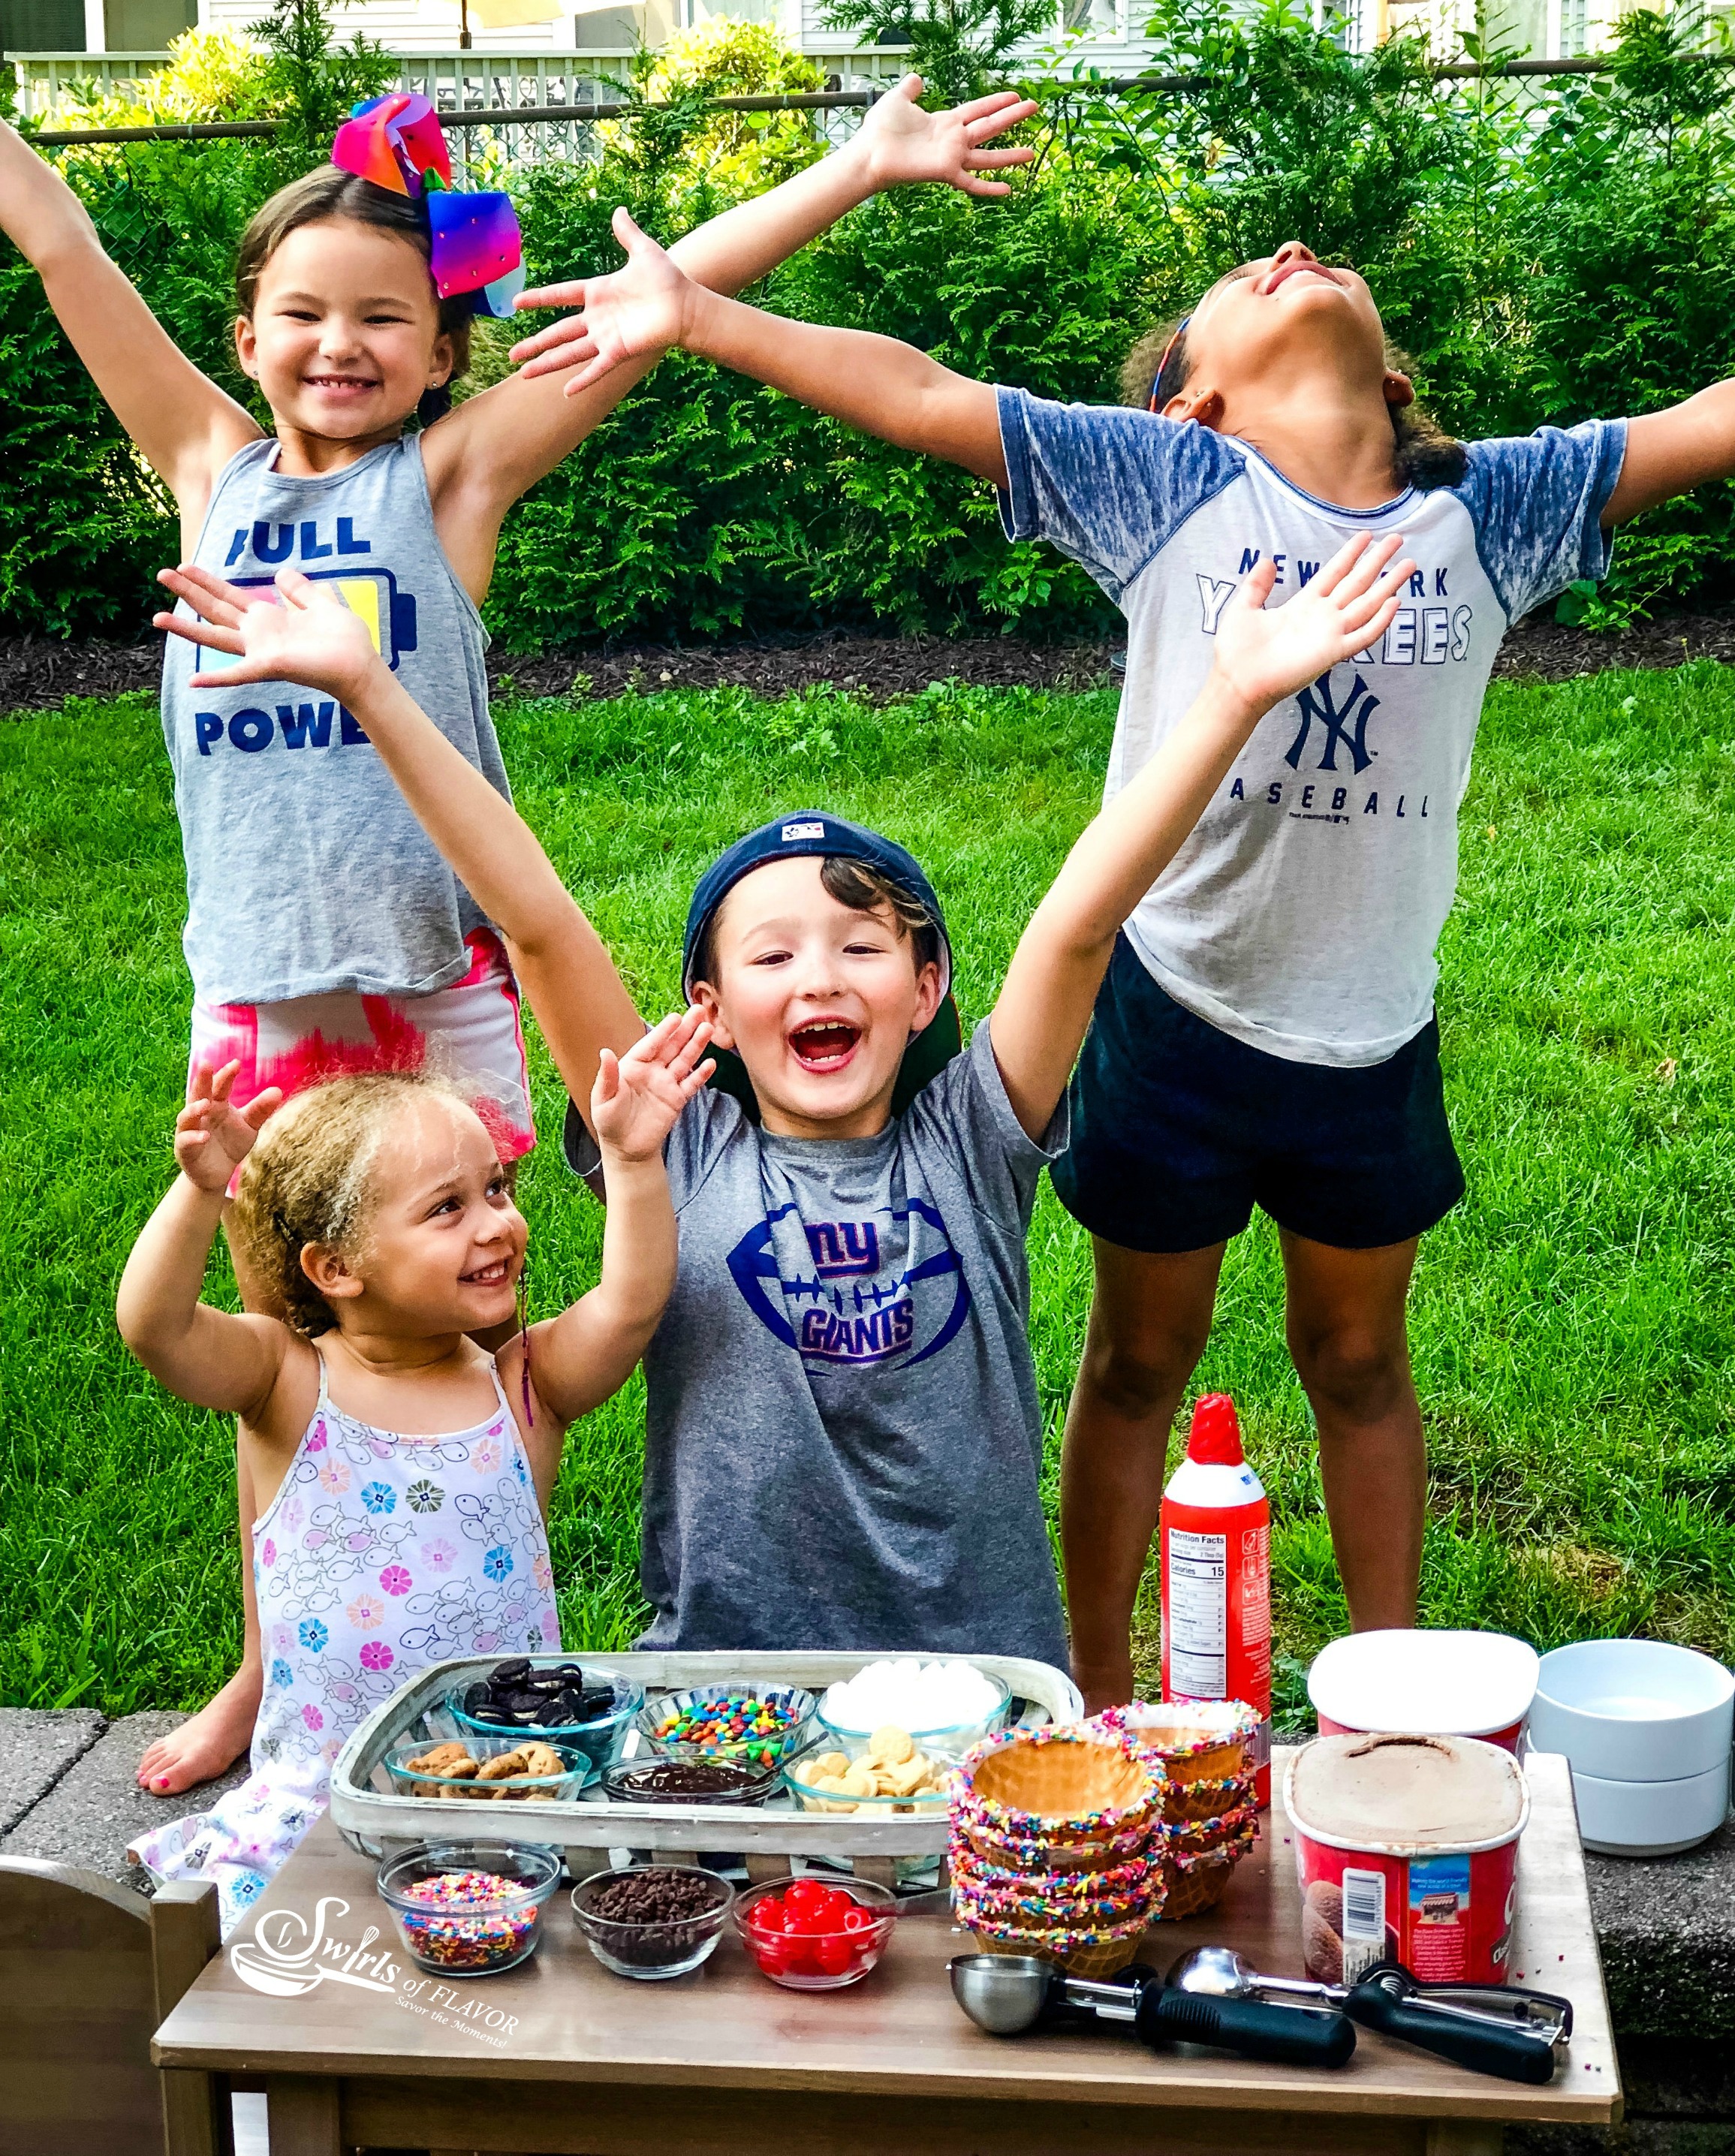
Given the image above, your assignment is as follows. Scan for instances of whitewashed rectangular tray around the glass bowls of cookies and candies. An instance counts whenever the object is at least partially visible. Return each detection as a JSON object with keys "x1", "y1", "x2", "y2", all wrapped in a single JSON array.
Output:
[{"x1": 332, "y1": 1652, "x2": 1084, "y2": 1886}]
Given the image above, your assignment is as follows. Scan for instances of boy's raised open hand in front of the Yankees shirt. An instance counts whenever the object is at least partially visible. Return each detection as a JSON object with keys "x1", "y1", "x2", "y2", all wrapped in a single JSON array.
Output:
[{"x1": 1215, "y1": 532, "x2": 1416, "y2": 712}]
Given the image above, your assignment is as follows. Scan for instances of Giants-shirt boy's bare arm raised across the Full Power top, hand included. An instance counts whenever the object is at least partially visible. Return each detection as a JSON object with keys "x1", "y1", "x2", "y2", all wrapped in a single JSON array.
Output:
[{"x1": 155, "y1": 567, "x2": 644, "y2": 1102}]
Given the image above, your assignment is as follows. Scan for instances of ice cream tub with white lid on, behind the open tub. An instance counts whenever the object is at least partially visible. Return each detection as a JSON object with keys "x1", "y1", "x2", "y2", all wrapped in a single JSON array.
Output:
[{"x1": 1309, "y1": 1632, "x2": 1541, "y2": 1753}]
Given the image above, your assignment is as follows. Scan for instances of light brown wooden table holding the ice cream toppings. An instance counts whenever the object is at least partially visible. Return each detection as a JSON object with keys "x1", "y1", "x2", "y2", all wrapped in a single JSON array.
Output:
[{"x1": 153, "y1": 1757, "x2": 1621, "y2": 2156}]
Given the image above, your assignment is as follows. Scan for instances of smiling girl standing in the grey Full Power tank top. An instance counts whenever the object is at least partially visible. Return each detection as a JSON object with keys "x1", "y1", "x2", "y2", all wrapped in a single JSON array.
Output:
[{"x1": 0, "y1": 76, "x2": 1035, "y2": 1796}]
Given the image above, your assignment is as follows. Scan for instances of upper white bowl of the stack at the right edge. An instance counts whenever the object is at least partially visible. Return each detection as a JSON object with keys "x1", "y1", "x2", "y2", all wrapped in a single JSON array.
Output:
[{"x1": 1530, "y1": 1639, "x2": 1735, "y2": 1783}]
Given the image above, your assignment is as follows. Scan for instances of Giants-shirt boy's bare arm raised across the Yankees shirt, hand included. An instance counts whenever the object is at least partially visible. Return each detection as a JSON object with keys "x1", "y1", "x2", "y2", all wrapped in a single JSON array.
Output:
[{"x1": 989, "y1": 534, "x2": 1416, "y2": 1138}]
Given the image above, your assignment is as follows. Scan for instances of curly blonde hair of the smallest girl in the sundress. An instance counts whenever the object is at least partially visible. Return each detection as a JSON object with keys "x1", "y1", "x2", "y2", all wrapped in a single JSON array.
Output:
[{"x1": 235, "y1": 1071, "x2": 461, "y2": 1339}]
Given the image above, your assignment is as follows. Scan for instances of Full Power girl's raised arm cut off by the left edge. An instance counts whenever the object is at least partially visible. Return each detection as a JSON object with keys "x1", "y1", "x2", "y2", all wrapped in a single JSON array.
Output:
[{"x1": 0, "y1": 121, "x2": 258, "y2": 534}]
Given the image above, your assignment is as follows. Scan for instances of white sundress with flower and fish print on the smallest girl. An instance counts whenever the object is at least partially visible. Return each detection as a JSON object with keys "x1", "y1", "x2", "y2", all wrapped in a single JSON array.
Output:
[{"x1": 127, "y1": 1356, "x2": 560, "y2": 1938}]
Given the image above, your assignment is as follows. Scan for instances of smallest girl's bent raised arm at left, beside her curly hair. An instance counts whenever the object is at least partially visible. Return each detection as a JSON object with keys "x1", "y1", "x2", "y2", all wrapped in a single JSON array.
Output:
[{"x1": 114, "y1": 1063, "x2": 289, "y2": 1421}]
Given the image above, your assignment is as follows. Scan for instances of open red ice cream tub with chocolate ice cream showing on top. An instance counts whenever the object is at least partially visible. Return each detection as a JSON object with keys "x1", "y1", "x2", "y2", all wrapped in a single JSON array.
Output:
[{"x1": 1282, "y1": 1731, "x2": 1530, "y2": 1983}]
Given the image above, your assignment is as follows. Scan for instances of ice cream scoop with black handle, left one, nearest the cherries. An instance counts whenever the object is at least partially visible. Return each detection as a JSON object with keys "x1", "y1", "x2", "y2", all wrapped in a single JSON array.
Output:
[{"x1": 946, "y1": 1953, "x2": 1356, "y2": 2065}]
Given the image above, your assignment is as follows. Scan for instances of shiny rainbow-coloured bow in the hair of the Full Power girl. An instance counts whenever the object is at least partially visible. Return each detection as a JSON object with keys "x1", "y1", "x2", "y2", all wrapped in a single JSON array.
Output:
[{"x1": 332, "y1": 91, "x2": 524, "y2": 317}]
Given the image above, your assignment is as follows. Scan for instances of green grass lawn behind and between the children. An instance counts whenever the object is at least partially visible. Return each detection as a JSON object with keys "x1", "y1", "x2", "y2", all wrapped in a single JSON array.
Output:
[{"x1": 0, "y1": 664, "x2": 1735, "y2": 1714}]
